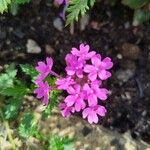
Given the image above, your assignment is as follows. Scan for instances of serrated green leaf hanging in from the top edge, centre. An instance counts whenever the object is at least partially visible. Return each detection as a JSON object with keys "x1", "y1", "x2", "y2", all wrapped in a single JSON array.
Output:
[{"x1": 66, "y1": 0, "x2": 95, "y2": 26}]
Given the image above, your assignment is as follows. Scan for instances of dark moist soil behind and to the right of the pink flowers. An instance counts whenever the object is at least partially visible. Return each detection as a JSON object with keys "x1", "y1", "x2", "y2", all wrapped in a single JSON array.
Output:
[{"x1": 0, "y1": 0, "x2": 150, "y2": 142}]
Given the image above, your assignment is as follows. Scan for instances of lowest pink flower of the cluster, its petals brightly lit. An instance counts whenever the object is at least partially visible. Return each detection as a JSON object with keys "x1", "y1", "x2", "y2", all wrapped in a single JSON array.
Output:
[{"x1": 82, "y1": 105, "x2": 107, "y2": 124}]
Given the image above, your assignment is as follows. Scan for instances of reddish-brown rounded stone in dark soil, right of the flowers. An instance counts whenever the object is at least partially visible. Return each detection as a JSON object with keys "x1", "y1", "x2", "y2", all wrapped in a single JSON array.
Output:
[{"x1": 120, "y1": 43, "x2": 140, "y2": 60}]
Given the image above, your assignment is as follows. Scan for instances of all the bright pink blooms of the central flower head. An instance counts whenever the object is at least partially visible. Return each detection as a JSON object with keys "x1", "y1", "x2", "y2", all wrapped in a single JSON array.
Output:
[{"x1": 35, "y1": 44, "x2": 113, "y2": 123}]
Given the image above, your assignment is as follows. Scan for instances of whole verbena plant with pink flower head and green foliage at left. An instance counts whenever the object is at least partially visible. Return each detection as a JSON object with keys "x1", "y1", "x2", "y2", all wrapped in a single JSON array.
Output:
[{"x1": 0, "y1": 44, "x2": 113, "y2": 150}]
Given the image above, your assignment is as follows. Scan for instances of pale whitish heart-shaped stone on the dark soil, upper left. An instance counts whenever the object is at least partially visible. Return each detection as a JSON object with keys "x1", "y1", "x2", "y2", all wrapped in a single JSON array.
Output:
[{"x1": 26, "y1": 39, "x2": 41, "y2": 54}]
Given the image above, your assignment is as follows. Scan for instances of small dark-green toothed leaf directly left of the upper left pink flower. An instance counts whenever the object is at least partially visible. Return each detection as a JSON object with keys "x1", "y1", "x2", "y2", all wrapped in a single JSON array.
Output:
[{"x1": 20, "y1": 64, "x2": 38, "y2": 81}]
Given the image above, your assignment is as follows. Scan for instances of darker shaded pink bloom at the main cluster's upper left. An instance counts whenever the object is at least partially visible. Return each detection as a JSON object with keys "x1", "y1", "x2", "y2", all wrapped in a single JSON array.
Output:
[{"x1": 65, "y1": 54, "x2": 84, "y2": 78}]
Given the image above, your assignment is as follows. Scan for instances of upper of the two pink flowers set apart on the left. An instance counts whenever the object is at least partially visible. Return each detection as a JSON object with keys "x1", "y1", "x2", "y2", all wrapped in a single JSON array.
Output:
[{"x1": 36, "y1": 57, "x2": 53, "y2": 78}]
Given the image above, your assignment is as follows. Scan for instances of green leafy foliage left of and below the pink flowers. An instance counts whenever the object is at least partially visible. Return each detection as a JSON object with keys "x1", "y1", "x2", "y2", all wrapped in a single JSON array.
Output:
[{"x1": 0, "y1": 64, "x2": 73, "y2": 150}]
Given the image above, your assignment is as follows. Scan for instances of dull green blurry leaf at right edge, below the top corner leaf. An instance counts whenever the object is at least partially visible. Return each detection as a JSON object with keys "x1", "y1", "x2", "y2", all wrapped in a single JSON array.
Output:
[{"x1": 133, "y1": 9, "x2": 150, "y2": 26}]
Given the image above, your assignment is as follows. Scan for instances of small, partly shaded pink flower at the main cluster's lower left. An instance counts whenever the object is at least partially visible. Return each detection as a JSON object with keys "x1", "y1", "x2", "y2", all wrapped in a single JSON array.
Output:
[{"x1": 59, "y1": 103, "x2": 75, "y2": 117}]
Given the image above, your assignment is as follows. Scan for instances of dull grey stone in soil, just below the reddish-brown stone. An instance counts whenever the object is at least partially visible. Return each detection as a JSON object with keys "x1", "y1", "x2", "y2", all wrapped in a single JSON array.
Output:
[{"x1": 116, "y1": 69, "x2": 134, "y2": 82}]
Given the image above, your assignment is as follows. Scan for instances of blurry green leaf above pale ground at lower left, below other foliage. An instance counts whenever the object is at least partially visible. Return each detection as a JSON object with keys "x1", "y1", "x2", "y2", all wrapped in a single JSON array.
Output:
[{"x1": 19, "y1": 113, "x2": 38, "y2": 138}]
